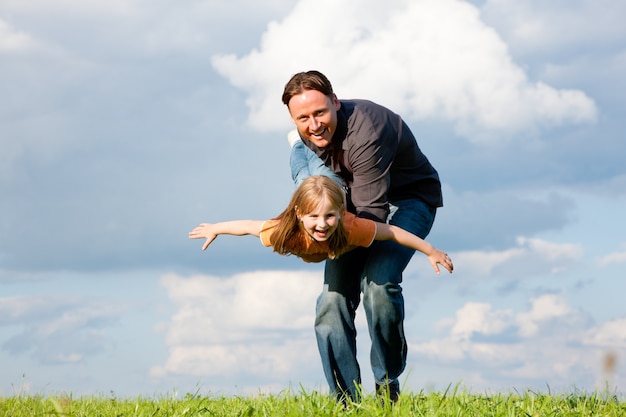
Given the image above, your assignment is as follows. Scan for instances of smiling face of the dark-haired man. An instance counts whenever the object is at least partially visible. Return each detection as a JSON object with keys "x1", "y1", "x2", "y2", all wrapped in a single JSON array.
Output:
[{"x1": 288, "y1": 90, "x2": 341, "y2": 148}]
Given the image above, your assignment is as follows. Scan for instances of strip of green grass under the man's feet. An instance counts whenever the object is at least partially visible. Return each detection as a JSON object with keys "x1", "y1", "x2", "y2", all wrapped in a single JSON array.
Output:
[{"x1": 0, "y1": 388, "x2": 626, "y2": 417}]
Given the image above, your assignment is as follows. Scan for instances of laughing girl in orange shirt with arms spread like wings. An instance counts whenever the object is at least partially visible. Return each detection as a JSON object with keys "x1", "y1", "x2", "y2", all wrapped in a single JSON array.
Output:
[{"x1": 189, "y1": 175, "x2": 454, "y2": 274}]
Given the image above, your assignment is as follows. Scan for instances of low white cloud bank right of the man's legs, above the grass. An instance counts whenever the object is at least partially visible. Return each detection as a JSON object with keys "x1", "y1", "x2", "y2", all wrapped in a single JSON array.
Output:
[{"x1": 409, "y1": 295, "x2": 626, "y2": 389}]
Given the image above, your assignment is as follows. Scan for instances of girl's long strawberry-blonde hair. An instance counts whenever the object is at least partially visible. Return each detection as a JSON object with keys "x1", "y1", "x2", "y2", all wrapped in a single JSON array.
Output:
[{"x1": 270, "y1": 175, "x2": 348, "y2": 259}]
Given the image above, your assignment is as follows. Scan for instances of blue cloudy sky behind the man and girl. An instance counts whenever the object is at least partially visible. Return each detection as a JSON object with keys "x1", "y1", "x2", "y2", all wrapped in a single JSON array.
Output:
[{"x1": 0, "y1": 0, "x2": 626, "y2": 397}]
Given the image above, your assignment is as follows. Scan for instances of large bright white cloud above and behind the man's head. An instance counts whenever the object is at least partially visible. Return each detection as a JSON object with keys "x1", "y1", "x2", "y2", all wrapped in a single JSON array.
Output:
[{"x1": 213, "y1": 0, "x2": 597, "y2": 141}]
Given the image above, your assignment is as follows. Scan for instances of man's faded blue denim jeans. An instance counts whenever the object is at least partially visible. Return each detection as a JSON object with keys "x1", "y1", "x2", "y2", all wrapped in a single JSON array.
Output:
[{"x1": 315, "y1": 199, "x2": 436, "y2": 398}]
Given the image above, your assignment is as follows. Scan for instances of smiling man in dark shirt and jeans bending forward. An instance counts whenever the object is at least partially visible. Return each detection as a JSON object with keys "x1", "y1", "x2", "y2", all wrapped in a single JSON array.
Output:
[{"x1": 282, "y1": 71, "x2": 443, "y2": 401}]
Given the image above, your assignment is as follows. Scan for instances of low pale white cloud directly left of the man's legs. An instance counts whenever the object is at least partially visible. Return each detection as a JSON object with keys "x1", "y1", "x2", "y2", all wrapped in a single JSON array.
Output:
[{"x1": 151, "y1": 271, "x2": 323, "y2": 377}]
